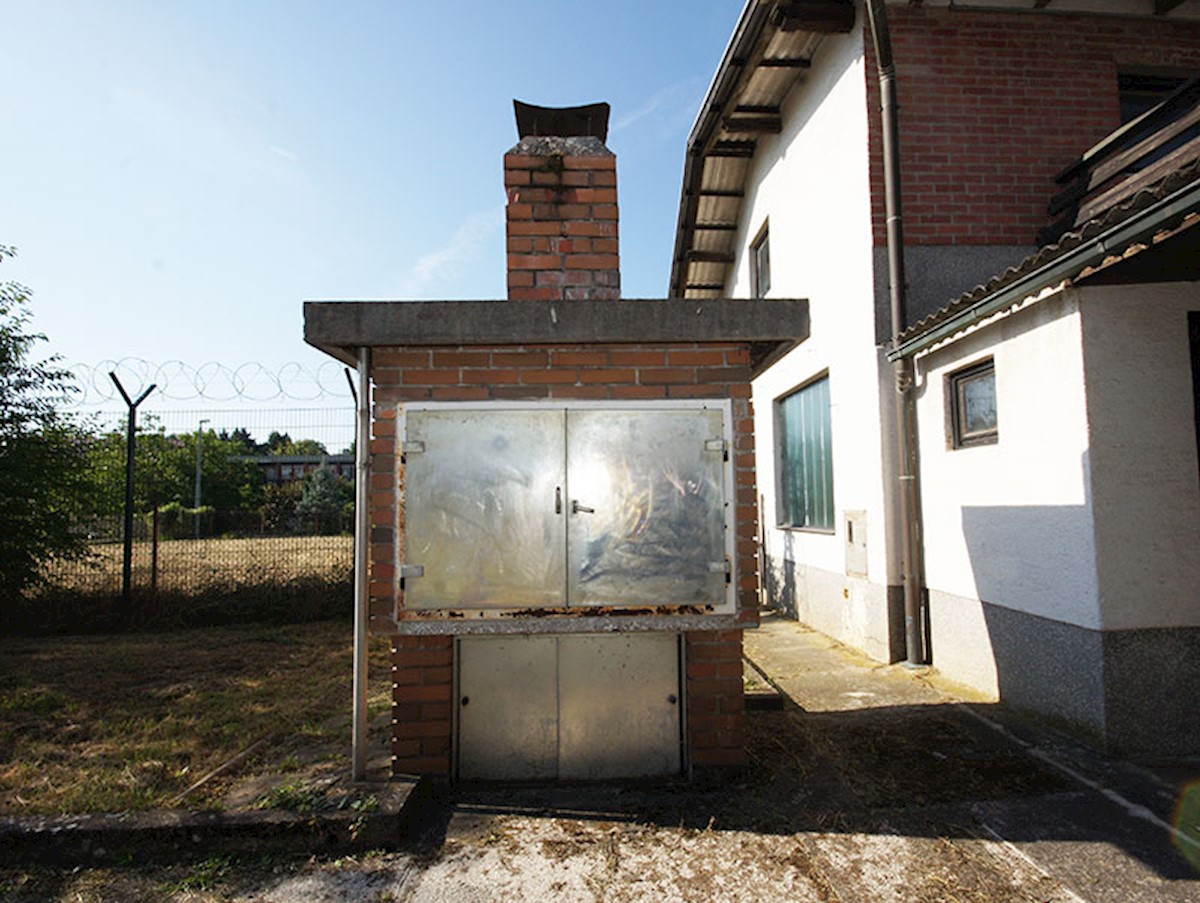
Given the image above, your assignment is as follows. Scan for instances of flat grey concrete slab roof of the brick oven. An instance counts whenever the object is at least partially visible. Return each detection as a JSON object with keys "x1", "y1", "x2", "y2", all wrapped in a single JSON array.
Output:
[{"x1": 304, "y1": 298, "x2": 809, "y2": 365}]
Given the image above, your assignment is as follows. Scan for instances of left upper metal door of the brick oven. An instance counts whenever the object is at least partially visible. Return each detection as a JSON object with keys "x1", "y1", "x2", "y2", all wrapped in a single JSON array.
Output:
[{"x1": 403, "y1": 408, "x2": 566, "y2": 609}]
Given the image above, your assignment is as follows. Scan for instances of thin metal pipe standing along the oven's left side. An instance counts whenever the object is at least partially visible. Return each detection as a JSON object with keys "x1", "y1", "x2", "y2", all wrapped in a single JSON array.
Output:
[{"x1": 347, "y1": 346, "x2": 371, "y2": 781}]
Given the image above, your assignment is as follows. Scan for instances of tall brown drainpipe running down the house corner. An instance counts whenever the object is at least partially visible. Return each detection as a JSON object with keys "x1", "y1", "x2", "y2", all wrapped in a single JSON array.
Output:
[{"x1": 866, "y1": 0, "x2": 929, "y2": 666}]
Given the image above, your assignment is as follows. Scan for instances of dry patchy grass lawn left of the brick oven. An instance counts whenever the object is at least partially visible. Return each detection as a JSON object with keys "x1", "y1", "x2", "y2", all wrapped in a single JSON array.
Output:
[{"x1": 0, "y1": 621, "x2": 391, "y2": 815}]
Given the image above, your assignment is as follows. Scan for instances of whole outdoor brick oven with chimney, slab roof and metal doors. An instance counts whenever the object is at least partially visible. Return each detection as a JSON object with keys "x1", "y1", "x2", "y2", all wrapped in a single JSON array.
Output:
[{"x1": 305, "y1": 104, "x2": 808, "y2": 779}]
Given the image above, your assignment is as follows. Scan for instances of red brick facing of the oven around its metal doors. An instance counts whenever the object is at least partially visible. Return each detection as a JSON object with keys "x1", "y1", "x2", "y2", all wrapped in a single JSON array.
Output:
[{"x1": 371, "y1": 342, "x2": 758, "y2": 773}]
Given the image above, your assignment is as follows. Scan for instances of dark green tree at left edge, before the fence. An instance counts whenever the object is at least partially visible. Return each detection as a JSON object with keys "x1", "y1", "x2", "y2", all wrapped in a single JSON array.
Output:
[{"x1": 0, "y1": 245, "x2": 90, "y2": 604}]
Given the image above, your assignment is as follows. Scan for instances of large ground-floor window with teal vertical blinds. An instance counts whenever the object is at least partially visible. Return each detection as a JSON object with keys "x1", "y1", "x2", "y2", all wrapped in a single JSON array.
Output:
[{"x1": 775, "y1": 376, "x2": 834, "y2": 531}]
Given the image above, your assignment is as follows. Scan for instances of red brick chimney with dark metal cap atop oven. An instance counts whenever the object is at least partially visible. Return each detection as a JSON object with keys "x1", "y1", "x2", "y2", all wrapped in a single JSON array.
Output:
[{"x1": 504, "y1": 102, "x2": 620, "y2": 301}]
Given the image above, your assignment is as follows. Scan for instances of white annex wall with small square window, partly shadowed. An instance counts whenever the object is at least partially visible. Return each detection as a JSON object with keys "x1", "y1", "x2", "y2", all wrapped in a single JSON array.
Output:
[{"x1": 917, "y1": 292, "x2": 1100, "y2": 629}]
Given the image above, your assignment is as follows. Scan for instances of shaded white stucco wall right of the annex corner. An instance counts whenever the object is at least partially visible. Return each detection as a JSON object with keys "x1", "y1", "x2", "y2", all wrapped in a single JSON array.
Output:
[{"x1": 1080, "y1": 282, "x2": 1200, "y2": 629}]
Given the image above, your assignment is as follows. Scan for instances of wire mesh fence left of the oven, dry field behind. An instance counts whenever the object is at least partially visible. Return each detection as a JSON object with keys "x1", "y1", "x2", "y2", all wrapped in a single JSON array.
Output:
[{"x1": 14, "y1": 399, "x2": 354, "y2": 632}]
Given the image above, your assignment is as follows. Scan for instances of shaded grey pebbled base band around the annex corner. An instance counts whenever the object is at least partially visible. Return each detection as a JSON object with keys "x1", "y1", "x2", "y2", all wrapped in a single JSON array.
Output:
[{"x1": 955, "y1": 603, "x2": 1200, "y2": 758}]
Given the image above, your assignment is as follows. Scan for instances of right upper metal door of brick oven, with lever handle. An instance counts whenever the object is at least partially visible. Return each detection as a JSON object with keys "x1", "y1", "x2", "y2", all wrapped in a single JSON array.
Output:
[{"x1": 566, "y1": 409, "x2": 726, "y2": 606}]
